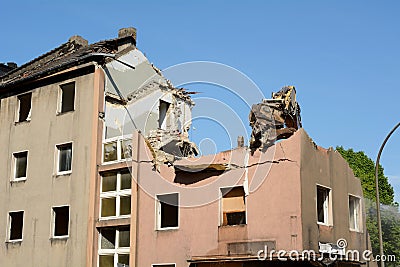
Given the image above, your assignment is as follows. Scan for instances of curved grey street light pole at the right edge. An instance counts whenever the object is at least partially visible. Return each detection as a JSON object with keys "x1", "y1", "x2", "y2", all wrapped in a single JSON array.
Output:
[{"x1": 375, "y1": 122, "x2": 400, "y2": 267}]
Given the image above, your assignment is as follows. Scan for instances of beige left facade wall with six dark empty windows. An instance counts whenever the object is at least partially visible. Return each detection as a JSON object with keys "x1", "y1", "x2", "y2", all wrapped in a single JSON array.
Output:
[{"x1": 0, "y1": 67, "x2": 97, "y2": 267}]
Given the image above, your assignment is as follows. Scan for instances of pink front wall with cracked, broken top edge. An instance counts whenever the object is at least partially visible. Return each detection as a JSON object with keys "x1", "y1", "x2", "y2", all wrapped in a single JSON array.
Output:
[{"x1": 134, "y1": 130, "x2": 303, "y2": 266}]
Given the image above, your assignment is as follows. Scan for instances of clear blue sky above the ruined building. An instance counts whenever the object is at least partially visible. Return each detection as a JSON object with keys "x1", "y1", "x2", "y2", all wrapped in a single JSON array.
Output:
[{"x1": 0, "y1": 0, "x2": 400, "y2": 202}]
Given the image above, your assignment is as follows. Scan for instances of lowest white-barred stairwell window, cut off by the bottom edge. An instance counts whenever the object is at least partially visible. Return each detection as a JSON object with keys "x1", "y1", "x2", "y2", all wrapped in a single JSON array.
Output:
[{"x1": 98, "y1": 225, "x2": 130, "y2": 267}]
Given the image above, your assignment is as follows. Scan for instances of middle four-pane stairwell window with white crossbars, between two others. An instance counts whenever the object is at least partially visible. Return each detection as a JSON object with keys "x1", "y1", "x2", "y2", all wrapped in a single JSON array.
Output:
[{"x1": 100, "y1": 170, "x2": 132, "y2": 218}]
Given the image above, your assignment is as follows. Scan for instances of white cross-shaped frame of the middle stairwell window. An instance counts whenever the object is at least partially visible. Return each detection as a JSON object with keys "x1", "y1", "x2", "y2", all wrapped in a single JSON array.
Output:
[{"x1": 99, "y1": 169, "x2": 133, "y2": 220}]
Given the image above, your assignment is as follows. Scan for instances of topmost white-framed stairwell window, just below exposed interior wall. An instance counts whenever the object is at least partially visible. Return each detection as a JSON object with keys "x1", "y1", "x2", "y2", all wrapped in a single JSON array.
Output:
[{"x1": 103, "y1": 135, "x2": 132, "y2": 162}]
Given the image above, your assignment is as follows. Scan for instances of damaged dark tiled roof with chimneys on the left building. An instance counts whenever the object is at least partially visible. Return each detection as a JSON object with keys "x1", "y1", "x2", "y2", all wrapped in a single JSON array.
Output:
[{"x1": 0, "y1": 32, "x2": 136, "y2": 90}]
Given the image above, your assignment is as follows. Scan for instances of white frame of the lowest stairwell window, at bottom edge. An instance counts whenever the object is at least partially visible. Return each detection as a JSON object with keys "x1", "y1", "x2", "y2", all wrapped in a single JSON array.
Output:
[{"x1": 97, "y1": 227, "x2": 131, "y2": 267}]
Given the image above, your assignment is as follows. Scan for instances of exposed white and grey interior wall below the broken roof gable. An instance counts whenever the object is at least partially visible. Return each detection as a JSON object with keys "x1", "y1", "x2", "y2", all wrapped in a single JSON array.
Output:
[{"x1": 105, "y1": 49, "x2": 192, "y2": 138}]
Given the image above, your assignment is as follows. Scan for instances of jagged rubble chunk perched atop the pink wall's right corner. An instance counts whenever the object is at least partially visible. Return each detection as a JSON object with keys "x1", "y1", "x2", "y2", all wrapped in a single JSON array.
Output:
[{"x1": 249, "y1": 86, "x2": 302, "y2": 152}]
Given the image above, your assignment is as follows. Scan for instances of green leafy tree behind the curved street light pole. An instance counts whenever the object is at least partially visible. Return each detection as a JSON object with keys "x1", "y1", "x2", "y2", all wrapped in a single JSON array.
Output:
[{"x1": 336, "y1": 146, "x2": 400, "y2": 267}]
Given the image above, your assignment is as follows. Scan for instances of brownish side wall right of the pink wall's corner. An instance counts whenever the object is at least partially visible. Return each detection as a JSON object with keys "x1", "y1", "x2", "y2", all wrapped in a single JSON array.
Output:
[{"x1": 300, "y1": 129, "x2": 366, "y2": 255}]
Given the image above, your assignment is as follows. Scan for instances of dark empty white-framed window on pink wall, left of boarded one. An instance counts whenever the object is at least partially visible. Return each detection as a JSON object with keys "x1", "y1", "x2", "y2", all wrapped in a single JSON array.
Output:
[{"x1": 157, "y1": 193, "x2": 179, "y2": 229}]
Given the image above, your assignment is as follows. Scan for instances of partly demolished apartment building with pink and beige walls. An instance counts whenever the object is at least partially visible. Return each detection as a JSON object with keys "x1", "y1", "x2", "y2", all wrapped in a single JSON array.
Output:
[{"x1": 0, "y1": 28, "x2": 372, "y2": 267}]
